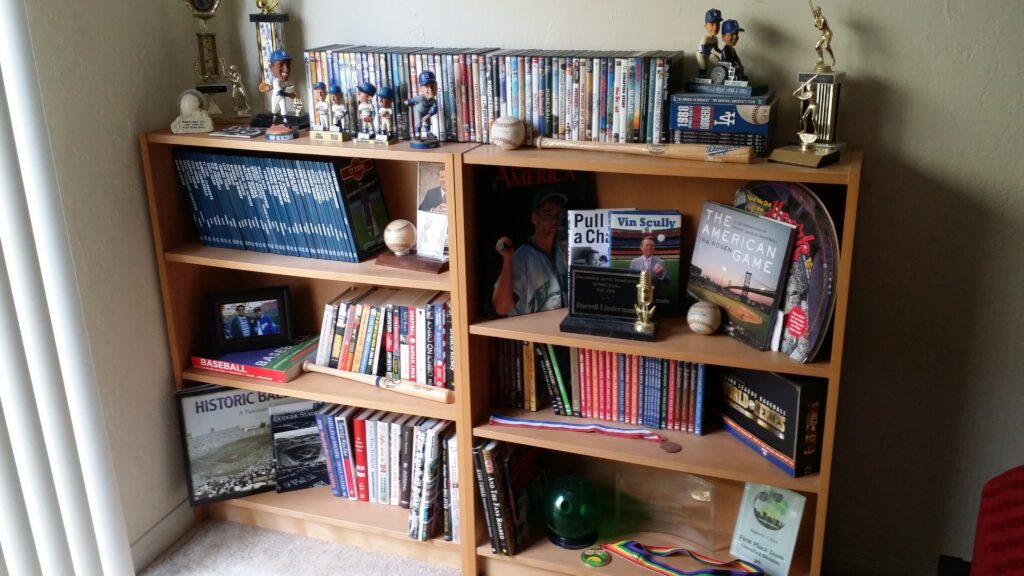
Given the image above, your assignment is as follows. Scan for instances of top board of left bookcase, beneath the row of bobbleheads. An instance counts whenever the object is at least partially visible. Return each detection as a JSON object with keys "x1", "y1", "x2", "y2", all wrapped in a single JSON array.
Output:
[{"x1": 145, "y1": 130, "x2": 479, "y2": 162}]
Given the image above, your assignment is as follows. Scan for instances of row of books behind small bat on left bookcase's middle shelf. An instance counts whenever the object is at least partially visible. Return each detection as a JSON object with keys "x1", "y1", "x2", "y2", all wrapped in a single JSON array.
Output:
[{"x1": 313, "y1": 285, "x2": 455, "y2": 389}]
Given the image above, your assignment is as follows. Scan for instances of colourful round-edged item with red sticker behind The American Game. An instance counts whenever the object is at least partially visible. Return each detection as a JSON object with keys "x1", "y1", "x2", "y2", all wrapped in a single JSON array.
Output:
[{"x1": 733, "y1": 181, "x2": 839, "y2": 362}]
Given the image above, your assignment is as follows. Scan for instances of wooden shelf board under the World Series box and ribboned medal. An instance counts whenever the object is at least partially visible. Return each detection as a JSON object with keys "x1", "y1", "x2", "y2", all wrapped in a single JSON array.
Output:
[{"x1": 473, "y1": 408, "x2": 821, "y2": 493}]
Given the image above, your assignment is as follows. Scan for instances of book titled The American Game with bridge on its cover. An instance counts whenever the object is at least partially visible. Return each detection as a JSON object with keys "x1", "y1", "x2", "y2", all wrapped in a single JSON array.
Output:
[{"x1": 686, "y1": 202, "x2": 795, "y2": 351}]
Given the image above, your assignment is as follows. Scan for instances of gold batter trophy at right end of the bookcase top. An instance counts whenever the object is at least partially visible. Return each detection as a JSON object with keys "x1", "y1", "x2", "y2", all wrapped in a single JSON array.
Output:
[{"x1": 768, "y1": 0, "x2": 846, "y2": 168}]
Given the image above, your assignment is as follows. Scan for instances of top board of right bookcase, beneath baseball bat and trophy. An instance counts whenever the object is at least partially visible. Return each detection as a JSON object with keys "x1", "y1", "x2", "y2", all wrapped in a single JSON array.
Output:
[{"x1": 463, "y1": 146, "x2": 861, "y2": 184}]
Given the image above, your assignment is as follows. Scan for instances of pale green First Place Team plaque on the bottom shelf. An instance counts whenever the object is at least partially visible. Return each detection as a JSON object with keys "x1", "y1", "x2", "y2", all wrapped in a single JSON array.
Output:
[{"x1": 729, "y1": 482, "x2": 807, "y2": 576}]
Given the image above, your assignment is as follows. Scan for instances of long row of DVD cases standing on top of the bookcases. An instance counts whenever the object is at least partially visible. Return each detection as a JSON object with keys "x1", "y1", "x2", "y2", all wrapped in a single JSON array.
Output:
[{"x1": 304, "y1": 44, "x2": 682, "y2": 143}]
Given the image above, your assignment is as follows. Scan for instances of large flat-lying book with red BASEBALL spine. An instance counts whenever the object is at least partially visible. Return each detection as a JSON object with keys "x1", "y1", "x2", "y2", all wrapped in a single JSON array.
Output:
[{"x1": 193, "y1": 336, "x2": 319, "y2": 382}]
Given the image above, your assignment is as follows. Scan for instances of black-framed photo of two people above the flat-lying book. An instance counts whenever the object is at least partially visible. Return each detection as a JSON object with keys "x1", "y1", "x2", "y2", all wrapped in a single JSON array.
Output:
[{"x1": 208, "y1": 286, "x2": 294, "y2": 354}]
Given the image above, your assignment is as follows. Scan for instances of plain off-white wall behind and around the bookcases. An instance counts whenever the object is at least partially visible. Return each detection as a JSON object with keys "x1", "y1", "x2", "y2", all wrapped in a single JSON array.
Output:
[{"x1": 24, "y1": 0, "x2": 1024, "y2": 574}]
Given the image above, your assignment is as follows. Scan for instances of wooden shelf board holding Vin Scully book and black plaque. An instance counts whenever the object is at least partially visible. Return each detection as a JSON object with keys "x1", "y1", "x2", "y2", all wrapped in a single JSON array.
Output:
[{"x1": 469, "y1": 308, "x2": 831, "y2": 378}]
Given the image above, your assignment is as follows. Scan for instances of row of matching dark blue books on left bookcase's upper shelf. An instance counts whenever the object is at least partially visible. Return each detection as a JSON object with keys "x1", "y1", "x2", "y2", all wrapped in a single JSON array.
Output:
[{"x1": 174, "y1": 148, "x2": 389, "y2": 262}]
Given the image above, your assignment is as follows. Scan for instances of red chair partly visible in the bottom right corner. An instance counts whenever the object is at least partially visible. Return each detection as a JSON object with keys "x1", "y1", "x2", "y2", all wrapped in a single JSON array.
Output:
[{"x1": 971, "y1": 465, "x2": 1024, "y2": 576}]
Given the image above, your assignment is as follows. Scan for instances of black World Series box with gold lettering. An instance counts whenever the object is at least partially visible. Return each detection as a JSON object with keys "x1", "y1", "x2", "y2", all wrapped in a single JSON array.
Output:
[{"x1": 718, "y1": 367, "x2": 826, "y2": 477}]
